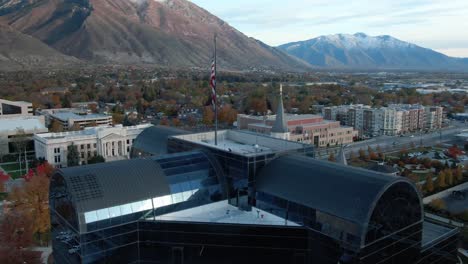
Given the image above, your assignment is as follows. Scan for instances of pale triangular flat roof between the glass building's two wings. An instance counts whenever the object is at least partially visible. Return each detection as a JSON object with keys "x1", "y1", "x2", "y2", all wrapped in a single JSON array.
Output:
[{"x1": 147, "y1": 200, "x2": 299, "y2": 226}]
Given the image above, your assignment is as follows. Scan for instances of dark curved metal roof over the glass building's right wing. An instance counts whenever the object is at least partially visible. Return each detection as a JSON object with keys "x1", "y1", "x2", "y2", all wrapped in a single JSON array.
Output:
[{"x1": 257, "y1": 156, "x2": 419, "y2": 228}]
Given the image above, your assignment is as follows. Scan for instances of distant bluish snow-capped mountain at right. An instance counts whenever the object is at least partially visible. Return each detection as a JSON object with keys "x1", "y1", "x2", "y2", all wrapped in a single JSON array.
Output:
[{"x1": 278, "y1": 33, "x2": 468, "y2": 71}]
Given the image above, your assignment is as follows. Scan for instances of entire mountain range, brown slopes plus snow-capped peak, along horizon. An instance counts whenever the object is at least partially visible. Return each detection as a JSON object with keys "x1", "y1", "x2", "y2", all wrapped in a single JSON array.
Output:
[{"x1": 0, "y1": 0, "x2": 468, "y2": 71}]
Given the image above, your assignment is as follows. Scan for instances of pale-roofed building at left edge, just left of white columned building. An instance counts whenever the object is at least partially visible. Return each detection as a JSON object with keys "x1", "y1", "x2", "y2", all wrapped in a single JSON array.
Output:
[{"x1": 0, "y1": 116, "x2": 49, "y2": 155}]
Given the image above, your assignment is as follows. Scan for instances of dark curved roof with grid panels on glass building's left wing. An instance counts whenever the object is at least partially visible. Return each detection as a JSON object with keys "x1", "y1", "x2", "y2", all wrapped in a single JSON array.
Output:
[{"x1": 57, "y1": 159, "x2": 171, "y2": 214}]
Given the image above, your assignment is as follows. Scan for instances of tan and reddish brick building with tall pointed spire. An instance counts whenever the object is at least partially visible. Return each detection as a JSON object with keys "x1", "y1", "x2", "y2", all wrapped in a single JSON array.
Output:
[{"x1": 237, "y1": 86, "x2": 358, "y2": 147}]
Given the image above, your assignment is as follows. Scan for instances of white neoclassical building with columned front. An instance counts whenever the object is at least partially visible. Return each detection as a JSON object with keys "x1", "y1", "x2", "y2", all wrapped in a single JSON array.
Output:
[{"x1": 34, "y1": 125, "x2": 151, "y2": 168}]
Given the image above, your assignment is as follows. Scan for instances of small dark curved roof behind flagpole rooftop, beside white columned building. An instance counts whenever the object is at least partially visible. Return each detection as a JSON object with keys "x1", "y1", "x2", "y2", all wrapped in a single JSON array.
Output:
[{"x1": 132, "y1": 126, "x2": 188, "y2": 158}]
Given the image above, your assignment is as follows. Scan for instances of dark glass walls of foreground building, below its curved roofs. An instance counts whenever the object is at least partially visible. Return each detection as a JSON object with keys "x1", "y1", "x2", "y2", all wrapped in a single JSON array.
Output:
[{"x1": 50, "y1": 139, "x2": 457, "y2": 264}]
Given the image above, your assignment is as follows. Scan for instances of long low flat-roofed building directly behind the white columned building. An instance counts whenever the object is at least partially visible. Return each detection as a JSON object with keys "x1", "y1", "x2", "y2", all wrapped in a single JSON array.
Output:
[{"x1": 38, "y1": 108, "x2": 112, "y2": 130}]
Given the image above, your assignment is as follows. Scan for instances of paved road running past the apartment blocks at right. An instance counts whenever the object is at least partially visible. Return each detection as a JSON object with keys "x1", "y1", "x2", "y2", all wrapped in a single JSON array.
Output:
[{"x1": 316, "y1": 122, "x2": 468, "y2": 159}]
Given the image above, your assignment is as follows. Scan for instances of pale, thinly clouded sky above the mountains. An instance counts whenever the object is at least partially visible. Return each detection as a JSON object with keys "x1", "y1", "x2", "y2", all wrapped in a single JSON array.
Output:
[{"x1": 192, "y1": 0, "x2": 468, "y2": 58}]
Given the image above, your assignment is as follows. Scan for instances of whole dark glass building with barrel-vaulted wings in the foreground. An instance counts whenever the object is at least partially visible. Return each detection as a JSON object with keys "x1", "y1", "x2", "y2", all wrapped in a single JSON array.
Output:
[{"x1": 50, "y1": 131, "x2": 459, "y2": 264}]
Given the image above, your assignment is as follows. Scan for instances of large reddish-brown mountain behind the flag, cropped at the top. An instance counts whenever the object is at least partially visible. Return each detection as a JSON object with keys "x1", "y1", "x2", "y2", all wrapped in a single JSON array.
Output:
[{"x1": 0, "y1": 0, "x2": 310, "y2": 70}]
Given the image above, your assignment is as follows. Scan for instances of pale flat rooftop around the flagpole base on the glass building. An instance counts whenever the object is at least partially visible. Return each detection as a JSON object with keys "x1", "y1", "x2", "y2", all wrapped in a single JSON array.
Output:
[{"x1": 173, "y1": 130, "x2": 310, "y2": 157}]
